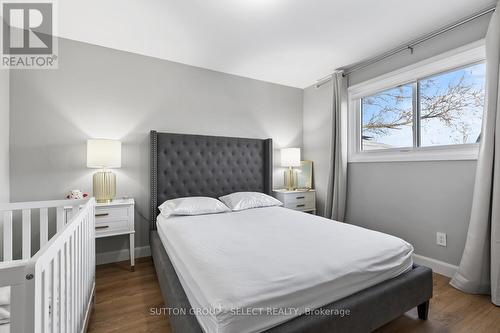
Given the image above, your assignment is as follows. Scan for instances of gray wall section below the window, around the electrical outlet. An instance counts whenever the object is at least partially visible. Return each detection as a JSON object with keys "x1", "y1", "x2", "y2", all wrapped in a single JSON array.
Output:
[{"x1": 347, "y1": 161, "x2": 476, "y2": 265}]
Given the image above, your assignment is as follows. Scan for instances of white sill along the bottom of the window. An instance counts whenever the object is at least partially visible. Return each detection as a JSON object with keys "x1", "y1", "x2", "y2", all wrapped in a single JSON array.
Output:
[{"x1": 348, "y1": 144, "x2": 479, "y2": 163}]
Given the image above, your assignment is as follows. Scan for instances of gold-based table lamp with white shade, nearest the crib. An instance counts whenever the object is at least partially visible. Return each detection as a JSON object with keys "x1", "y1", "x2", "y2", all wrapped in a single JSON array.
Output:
[{"x1": 87, "y1": 139, "x2": 122, "y2": 203}]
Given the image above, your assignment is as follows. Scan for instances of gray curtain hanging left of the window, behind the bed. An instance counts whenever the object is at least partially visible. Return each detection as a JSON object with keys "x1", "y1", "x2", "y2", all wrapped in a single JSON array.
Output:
[{"x1": 325, "y1": 72, "x2": 347, "y2": 221}]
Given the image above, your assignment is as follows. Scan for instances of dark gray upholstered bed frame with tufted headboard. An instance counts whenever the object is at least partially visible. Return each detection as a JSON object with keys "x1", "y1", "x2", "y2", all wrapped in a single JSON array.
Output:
[{"x1": 150, "y1": 131, "x2": 432, "y2": 333}]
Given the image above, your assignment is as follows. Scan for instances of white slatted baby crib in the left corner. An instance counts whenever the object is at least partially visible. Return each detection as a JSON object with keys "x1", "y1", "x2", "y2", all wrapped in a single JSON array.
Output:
[{"x1": 0, "y1": 198, "x2": 95, "y2": 333}]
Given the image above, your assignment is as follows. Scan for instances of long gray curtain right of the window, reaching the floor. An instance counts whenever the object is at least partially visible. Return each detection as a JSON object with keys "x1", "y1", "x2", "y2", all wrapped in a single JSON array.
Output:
[{"x1": 450, "y1": 1, "x2": 500, "y2": 305}]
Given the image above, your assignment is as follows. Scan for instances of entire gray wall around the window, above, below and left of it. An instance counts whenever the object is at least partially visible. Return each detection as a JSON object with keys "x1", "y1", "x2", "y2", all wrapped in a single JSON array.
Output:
[{"x1": 303, "y1": 16, "x2": 490, "y2": 265}]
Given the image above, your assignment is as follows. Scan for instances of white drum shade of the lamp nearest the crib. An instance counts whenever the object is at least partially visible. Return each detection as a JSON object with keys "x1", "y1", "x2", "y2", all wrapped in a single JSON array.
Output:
[{"x1": 87, "y1": 139, "x2": 122, "y2": 169}]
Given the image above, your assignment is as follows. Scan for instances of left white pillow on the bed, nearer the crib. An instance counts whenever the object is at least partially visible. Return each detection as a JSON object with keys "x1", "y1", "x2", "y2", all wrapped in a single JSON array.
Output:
[{"x1": 158, "y1": 197, "x2": 231, "y2": 217}]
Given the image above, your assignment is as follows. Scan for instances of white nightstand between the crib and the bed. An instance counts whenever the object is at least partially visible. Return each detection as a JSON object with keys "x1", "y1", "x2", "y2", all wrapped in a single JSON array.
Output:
[{"x1": 66, "y1": 199, "x2": 135, "y2": 271}]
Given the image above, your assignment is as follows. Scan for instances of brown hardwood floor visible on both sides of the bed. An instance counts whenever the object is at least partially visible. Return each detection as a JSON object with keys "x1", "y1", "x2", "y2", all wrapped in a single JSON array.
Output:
[{"x1": 88, "y1": 257, "x2": 500, "y2": 333}]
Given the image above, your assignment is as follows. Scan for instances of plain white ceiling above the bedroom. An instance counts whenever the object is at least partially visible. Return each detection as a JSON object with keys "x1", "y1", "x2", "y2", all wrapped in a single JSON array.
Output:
[{"x1": 58, "y1": 0, "x2": 494, "y2": 88}]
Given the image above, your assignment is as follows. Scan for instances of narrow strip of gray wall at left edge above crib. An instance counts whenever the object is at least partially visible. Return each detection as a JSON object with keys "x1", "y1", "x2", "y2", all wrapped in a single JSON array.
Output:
[{"x1": 0, "y1": 69, "x2": 9, "y2": 202}]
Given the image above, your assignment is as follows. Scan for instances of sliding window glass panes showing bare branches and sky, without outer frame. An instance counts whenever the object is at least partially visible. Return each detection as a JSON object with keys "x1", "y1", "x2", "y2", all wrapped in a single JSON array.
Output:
[{"x1": 361, "y1": 63, "x2": 485, "y2": 150}]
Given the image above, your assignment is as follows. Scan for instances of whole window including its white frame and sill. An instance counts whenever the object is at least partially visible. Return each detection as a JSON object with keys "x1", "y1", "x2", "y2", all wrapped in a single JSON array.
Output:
[{"x1": 349, "y1": 42, "x2": 486, "y2": 161}]
